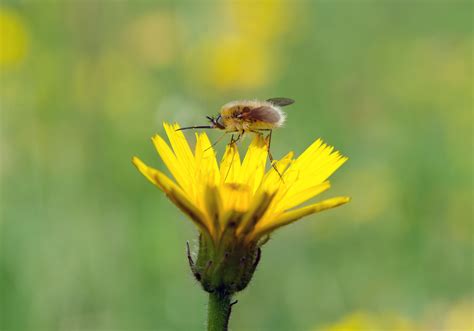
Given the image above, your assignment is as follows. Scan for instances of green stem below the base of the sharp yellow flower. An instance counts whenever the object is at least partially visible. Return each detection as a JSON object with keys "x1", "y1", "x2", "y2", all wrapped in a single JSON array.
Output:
[{"x1": 207, "y1": 291, "x2": 232, "y2": 331}]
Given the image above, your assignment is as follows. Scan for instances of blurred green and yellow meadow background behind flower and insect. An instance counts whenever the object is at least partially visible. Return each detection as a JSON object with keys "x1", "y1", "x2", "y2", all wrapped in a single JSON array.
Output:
[{"x1": 0, "y1": 0, "x2": 474, "y2": 331}]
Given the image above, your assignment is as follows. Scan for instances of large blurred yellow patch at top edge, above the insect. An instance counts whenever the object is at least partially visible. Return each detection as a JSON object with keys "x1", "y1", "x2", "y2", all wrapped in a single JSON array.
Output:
[{"x1": 186, "y1": 0, "x2": 296, "y2": 91}]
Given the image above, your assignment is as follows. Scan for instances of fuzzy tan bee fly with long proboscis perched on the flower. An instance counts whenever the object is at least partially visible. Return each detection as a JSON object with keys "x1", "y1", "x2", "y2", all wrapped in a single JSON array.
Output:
[{"x1": 178, "y1": 98, "x2": 295, "y2": 177}]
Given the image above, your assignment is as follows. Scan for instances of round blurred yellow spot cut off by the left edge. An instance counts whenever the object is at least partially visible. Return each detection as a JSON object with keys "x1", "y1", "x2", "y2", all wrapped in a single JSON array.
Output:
[{"x1": 0, "y1": 8, "x2": 28, "y2": 67}]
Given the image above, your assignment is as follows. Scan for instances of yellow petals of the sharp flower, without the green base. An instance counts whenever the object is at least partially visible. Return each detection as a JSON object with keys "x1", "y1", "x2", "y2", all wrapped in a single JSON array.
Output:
[{"x1": 133, "y1": 124, "x2": 349, "y2": 244}]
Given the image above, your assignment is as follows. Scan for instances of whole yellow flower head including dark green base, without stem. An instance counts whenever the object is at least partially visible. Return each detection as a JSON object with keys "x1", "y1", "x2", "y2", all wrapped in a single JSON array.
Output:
[{"x1": 133, "y1": 124, "x2": 349, "y2": 297}]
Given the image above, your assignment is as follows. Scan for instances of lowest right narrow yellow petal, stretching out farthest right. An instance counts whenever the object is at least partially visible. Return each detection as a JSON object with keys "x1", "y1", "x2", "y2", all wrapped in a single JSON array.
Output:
[{"x1": 253, "y1": 197, "x2": 350, "y2": 238}]
